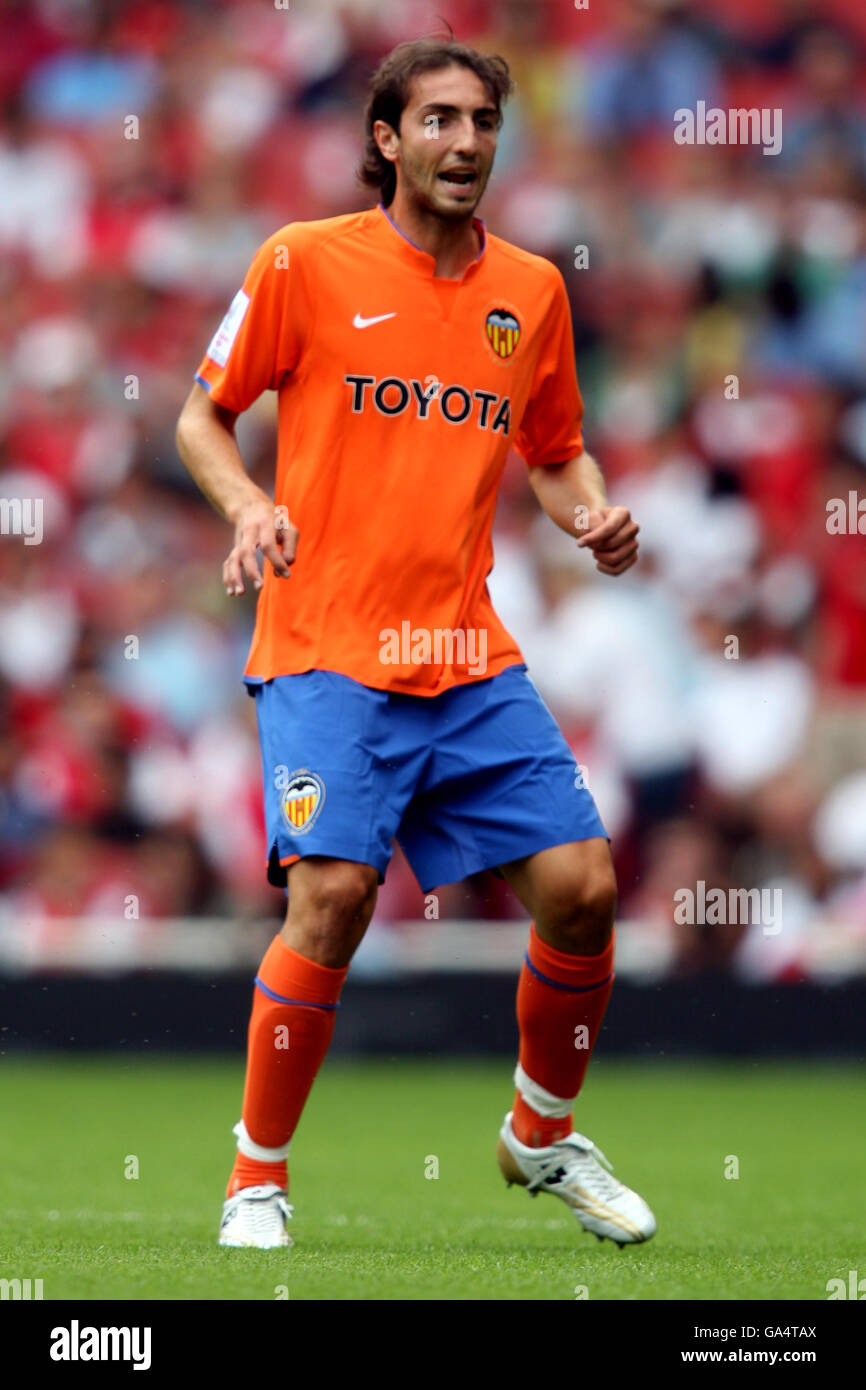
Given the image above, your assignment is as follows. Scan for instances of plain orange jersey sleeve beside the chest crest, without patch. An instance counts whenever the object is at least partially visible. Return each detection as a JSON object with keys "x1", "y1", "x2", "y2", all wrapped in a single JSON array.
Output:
[{"x1": 514, "y1": 271, "x2": 584, "y2": 467}]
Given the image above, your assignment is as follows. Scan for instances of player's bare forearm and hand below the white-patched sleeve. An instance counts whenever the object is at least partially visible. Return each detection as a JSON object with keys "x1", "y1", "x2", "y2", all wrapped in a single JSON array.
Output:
[{"x1": 175, "y1": 382, "x2": 297, "y2": 595}]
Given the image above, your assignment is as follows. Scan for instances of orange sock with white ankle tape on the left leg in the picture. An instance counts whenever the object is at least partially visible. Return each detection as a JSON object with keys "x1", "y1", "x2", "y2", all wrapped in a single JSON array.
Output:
[{"x1": 225, "y1": 937, "x2": 349, "y2": 1197}]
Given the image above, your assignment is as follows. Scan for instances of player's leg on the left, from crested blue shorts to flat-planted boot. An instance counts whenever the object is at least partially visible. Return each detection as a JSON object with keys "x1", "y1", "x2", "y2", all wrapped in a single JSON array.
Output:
[{"x1": 220, "y1": 671, "x2": 424, "y2": 1248}]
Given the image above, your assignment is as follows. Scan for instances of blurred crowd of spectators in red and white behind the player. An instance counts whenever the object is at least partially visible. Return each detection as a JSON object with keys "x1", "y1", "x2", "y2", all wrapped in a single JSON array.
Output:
[{"x1": 0, "y1": 0, "x2": 866, "y2": 980}]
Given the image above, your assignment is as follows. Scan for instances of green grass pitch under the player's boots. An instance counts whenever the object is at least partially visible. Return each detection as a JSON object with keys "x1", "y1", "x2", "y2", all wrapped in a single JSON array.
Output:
[{"x1": 0, "y1": 1056, "x2": 866, "y2": 1300}]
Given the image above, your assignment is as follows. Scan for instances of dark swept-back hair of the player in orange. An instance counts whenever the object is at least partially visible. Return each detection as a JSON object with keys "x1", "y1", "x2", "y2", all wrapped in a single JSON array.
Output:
[{"x1": 357, "y1": 36, "x2": 514, "y2": 207}]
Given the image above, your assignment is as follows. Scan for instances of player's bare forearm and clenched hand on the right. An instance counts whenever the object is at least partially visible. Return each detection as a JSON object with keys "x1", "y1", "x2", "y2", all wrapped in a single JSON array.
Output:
[{"x1": 530, "y1": 449, "x2": 639, "y2": 574}]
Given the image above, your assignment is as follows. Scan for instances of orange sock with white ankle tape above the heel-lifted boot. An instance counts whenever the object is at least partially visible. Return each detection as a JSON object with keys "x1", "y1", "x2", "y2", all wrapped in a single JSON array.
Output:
[{"x1": 512, "y1": 923, "x2": 614, "y2": 1148}]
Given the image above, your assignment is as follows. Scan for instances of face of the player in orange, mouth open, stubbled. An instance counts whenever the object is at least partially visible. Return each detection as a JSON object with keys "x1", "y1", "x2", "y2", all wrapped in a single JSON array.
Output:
[{"x1": 391, "y1": 64, "x2": 498, "y2": 221}]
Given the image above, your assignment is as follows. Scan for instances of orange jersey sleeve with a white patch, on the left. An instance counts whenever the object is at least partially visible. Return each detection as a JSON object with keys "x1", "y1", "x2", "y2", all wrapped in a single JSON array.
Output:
[{"x1": 196, "y1": 228, "x2": 306, "y2": 414}]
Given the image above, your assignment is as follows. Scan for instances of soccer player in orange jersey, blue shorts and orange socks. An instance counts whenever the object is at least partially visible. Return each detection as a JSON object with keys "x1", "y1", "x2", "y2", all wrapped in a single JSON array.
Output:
[{"x1": 178, "y1": 39, "x2": 656, "y2": 1248}]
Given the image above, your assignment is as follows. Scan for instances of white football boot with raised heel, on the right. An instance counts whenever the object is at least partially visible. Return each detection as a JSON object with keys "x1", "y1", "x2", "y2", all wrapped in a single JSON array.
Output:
[{"x1": 496, "y1": 1111, "x2": 656, "y2": 1248}]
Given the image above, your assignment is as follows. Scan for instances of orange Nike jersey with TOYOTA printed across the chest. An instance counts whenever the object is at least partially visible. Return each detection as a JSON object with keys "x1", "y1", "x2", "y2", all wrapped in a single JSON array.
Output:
[{"x1": 197, "y1": 204, "x2": 582, "y2": 695}]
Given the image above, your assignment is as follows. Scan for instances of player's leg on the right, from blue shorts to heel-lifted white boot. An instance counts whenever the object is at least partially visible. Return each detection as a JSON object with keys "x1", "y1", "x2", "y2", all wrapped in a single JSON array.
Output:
[{"x1": 398, "y1": 667, "x2": 656, "y2": 1244}]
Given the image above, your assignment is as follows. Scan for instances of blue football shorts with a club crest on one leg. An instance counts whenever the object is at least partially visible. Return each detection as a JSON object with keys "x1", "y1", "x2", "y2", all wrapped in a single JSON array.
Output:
[{"x1": 249, "y1": 666, "x2": 610, "y2": 892}]
